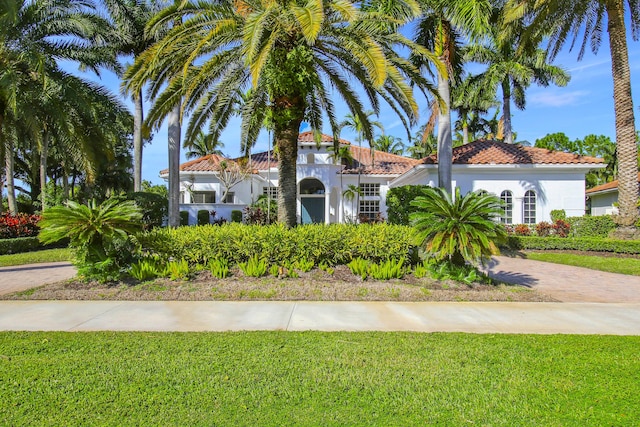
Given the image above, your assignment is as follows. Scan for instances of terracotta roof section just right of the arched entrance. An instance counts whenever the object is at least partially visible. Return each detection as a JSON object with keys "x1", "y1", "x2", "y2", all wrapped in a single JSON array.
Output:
[{"x1": 343, "y1": 145, "x2": 421, "y2": 175}]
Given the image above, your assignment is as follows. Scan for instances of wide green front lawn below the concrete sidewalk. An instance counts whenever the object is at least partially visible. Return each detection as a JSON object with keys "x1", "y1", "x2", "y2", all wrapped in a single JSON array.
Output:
[{"x1": 0, "y1": 332, "x2": 640, "y2": 426}]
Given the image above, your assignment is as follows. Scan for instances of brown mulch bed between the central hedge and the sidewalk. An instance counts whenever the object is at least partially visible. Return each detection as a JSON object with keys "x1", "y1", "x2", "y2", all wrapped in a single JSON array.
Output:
[{"x1": 0, "y1": 266, "x2": 555, "y2": 302}]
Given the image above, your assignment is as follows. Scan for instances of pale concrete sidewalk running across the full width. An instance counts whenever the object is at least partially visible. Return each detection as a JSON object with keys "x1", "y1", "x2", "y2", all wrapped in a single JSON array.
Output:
[{"x1": 0, "y1": 301, "x2": 640, "y2": 335}]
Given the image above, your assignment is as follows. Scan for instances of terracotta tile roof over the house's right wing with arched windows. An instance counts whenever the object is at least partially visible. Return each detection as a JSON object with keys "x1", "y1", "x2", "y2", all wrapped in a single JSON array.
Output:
[{"x1": 422, "y1": 140, "x2": 604, "y2": 165}]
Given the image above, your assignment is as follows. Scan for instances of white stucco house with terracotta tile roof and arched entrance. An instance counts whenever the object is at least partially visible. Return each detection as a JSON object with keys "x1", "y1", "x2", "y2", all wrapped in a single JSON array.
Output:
[{"x1": 160, "y1": 132, "x2": 604, "y2": 224}]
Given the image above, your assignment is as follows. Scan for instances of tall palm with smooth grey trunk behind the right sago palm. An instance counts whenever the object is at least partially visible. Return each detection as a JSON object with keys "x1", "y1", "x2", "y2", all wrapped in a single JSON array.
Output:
[{"x1": 414, "y1": 0, "x2": 491, "y2": 193}]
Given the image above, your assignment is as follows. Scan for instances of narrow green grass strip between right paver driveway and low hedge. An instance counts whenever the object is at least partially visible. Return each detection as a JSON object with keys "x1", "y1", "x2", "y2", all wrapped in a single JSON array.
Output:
[{"x1": 526, "y1": 252, "x2": 640, "y2": 276}]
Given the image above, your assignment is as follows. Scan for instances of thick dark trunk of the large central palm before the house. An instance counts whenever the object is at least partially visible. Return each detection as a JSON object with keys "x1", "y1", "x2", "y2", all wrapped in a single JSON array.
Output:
[{"x1": 273, "y1": 115, "x2": 302, "y2": 227}]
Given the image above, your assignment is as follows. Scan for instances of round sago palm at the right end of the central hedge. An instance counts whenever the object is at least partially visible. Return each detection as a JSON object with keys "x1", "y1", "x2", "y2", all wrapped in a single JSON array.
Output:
[{"x1": 410, "y1": 187, "x2": 506, "y2": 265}]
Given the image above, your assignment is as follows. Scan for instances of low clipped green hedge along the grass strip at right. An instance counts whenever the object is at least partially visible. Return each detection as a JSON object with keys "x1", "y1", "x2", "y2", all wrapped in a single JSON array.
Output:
[{"x1": 507, "y1": 236, "x2": 640, "y2": 254}]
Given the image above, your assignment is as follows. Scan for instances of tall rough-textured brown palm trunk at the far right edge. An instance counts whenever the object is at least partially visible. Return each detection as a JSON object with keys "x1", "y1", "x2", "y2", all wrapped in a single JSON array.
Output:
[{"x1": 605, "y1": 0, "x2": 638, "y2": 227}]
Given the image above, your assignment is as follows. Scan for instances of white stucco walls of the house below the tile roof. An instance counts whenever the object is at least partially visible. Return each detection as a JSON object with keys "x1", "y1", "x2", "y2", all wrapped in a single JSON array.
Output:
[{"x1": 164, "y1": 135, "x2": 593, "y2": 224}]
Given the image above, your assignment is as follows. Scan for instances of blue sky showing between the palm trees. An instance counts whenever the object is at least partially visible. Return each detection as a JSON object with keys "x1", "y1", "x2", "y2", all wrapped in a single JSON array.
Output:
[{"x1": 74, "y1": 34, "x2": 640, "y2": 184}]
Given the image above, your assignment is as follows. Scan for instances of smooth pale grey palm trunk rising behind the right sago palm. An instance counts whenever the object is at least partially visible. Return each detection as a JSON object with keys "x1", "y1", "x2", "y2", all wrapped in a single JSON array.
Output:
[{"x1": 438, "y1": 73, "x2": 453, "y2": 194}]
